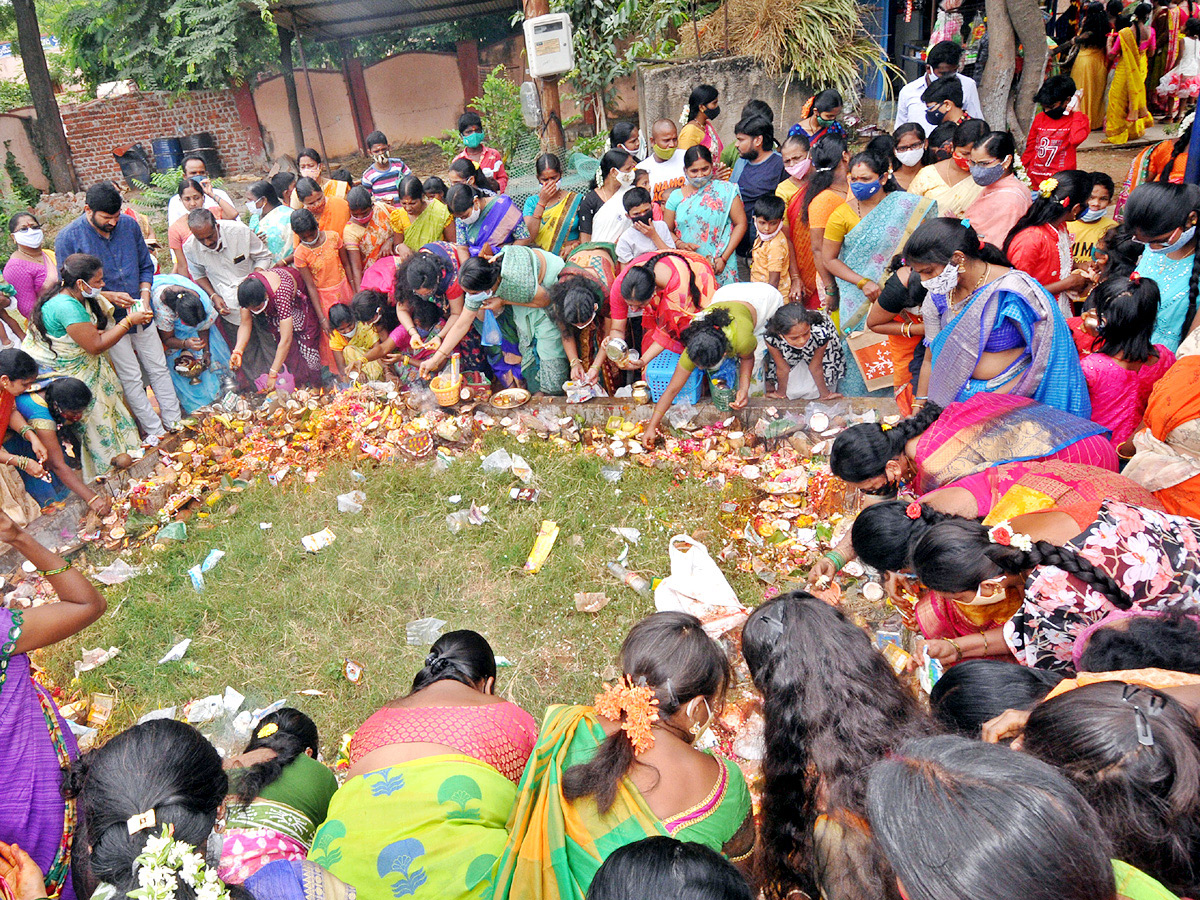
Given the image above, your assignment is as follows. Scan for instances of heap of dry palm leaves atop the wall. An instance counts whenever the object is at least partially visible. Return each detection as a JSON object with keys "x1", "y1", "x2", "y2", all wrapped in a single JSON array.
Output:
[{"x1": 679, "y1": 0, "x2": 889, "y2": 94}]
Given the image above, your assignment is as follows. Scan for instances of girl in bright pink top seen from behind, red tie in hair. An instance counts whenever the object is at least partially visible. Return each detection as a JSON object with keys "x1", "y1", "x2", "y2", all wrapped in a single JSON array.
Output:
[{"x1": 1082, "y1": 274, "x2": 1175, "y2": 446}]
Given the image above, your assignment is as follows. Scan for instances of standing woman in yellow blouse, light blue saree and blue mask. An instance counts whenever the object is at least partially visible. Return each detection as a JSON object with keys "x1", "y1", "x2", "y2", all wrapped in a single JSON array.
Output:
[{"x1": 821, "y1": 152, "x2": 937, "y2": 396}]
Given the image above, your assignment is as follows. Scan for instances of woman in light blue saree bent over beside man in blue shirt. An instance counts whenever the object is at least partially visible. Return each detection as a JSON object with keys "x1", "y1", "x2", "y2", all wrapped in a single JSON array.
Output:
[{"x1": 150, "y1": 275, "x2": 229, "y2": 415}]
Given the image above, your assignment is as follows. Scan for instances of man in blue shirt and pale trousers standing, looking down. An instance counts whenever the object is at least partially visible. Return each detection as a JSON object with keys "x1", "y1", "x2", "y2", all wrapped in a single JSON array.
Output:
[{"x1": 54, "y1": 181, "x2": 182, "y2": 445}]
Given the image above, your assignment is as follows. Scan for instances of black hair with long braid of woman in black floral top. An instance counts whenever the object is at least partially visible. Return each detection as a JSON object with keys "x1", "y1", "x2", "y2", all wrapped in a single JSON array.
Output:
[{"x1": 912, "y1": 518, "x2": 1133, "y2": 610}]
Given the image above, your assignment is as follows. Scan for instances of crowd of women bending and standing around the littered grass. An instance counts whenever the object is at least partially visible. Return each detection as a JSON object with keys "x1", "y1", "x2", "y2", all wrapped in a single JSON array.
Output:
[{"x1": 9, "y1": 68, "x2": 1200, "y2": 900}]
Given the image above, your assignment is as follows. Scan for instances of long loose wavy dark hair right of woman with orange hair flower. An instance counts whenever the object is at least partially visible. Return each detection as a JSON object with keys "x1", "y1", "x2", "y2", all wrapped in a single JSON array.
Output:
[{"x1": 742, "y1": 590, "x2": 937, "y2": 900}]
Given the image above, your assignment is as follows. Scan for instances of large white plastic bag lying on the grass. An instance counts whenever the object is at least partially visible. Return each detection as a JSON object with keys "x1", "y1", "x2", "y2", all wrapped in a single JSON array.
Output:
[{"x1": 654, "y1": 534, "x2": 750, "y2": 640}]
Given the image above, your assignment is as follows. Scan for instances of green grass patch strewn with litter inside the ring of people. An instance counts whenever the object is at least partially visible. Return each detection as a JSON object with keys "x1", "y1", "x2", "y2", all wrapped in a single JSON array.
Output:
[{"x1": 40, "y1": 436, "x2": 763, "y2": 758}]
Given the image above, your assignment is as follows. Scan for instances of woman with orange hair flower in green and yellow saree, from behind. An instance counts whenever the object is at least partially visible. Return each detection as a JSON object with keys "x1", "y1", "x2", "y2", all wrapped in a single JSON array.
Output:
[{"x1": 494, "y1": 612, "x2": 755, "y2": 900}]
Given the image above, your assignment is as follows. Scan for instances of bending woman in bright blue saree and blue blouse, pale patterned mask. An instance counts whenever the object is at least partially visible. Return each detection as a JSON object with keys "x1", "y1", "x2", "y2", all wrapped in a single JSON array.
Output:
[{"x1": 905, "y1": 218, "x2": 1092, "y2": 419}]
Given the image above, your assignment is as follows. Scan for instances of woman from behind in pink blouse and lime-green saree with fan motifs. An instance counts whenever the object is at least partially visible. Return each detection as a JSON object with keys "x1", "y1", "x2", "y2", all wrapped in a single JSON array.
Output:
[{"x1": 308, "y1": 631, "x2": 538, "y2": 900}]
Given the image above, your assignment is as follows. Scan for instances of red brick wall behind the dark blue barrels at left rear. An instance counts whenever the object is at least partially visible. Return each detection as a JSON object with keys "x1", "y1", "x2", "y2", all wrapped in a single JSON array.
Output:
[{"x1": 62, "y1": 90, "x2": 263, "y2": 185}]
